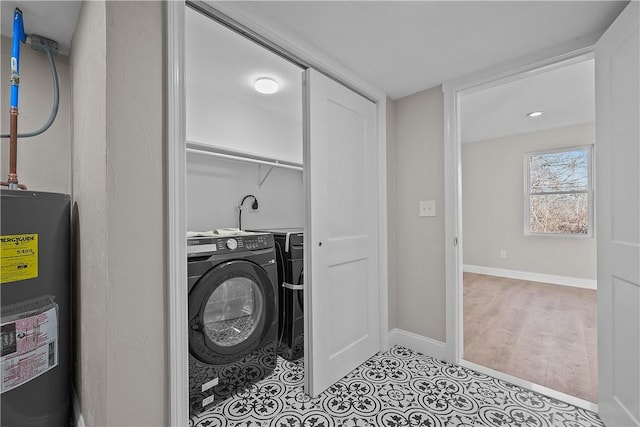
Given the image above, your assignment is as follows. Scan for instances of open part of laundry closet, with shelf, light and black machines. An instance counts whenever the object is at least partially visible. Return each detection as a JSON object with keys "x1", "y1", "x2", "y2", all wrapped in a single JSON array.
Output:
[{"x1": 184, "y1": 3, "x2": 307, "y2": 419}]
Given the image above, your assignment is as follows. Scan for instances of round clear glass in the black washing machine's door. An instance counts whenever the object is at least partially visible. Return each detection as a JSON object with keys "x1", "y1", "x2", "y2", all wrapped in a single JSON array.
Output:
[{"x1": 203, "y1": 276, "x2": 264, "y2": 347}]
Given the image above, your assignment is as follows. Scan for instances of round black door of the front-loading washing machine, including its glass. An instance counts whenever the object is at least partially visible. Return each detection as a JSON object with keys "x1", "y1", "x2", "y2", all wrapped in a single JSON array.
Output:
[{"x1": 189, "y1": 260, "x2": 277, "y2": 365}]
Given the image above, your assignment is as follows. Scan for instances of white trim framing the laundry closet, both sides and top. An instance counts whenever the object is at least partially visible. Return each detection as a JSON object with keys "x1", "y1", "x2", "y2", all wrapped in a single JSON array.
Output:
[{"x1": 164, "y1": 1, "x2": 388, "y2": 426}]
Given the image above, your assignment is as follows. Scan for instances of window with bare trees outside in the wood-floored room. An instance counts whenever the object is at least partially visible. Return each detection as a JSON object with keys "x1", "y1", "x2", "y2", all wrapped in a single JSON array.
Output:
[{"x1": 525, "y1": 146, "x2": 593, "y2": 236}]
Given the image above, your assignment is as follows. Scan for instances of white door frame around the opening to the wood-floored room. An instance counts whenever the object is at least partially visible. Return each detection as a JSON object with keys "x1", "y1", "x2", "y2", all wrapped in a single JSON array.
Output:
[{"x1": 442, "y1": 35, "x2": 599, "y2": 411}]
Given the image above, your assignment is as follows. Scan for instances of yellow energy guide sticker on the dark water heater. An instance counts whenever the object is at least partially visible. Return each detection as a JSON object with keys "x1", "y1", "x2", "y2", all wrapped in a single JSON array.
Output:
[{"x1": 0, "y1": 234, "x2": 38, "y2": 283}]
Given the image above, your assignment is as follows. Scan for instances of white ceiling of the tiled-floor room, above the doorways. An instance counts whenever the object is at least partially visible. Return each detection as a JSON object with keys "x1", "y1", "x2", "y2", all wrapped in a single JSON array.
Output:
[{"x1": 222, "y1": 0, "x2": 627, "y2": 99}]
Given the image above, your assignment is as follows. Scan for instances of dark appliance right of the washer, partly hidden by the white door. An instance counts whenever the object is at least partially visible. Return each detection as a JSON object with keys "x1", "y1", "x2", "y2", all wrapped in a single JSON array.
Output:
[{"x1": 249, "y1": 228, "x2": 304, "y2": 360}]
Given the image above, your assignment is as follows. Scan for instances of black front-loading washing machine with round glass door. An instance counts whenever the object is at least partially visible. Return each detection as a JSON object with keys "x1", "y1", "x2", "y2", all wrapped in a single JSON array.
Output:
[{"x1": 187, "y1": 232, "x2": 278, "y2": 415}]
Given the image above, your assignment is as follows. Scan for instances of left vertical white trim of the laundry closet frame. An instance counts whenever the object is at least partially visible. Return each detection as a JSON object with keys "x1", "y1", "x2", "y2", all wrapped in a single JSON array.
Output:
[{"x1": 163, "y1": 1, "x2": 189, "y2": 426}]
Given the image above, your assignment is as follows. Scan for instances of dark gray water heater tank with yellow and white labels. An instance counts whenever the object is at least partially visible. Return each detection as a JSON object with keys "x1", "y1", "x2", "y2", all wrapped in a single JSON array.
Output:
[{"x1": 0, "y1": 190, "x2": 71, "y2": 427}]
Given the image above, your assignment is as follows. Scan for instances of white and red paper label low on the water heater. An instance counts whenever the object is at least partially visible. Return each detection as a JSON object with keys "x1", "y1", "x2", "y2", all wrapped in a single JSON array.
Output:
[{"x1": 0, "y1": 305, "x2": 58, "y2": 393}]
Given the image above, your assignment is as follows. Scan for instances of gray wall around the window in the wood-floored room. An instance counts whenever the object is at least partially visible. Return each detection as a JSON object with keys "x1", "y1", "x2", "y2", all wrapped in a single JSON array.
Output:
[{"x1": 462, "y1": 124, "x2": 596, "y2": 280}]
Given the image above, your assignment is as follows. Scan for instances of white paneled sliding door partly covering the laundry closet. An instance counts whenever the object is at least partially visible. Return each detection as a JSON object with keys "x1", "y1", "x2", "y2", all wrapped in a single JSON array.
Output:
[{"x1": 304, "y1": 70, "x2": 380, "y2": 396}]
